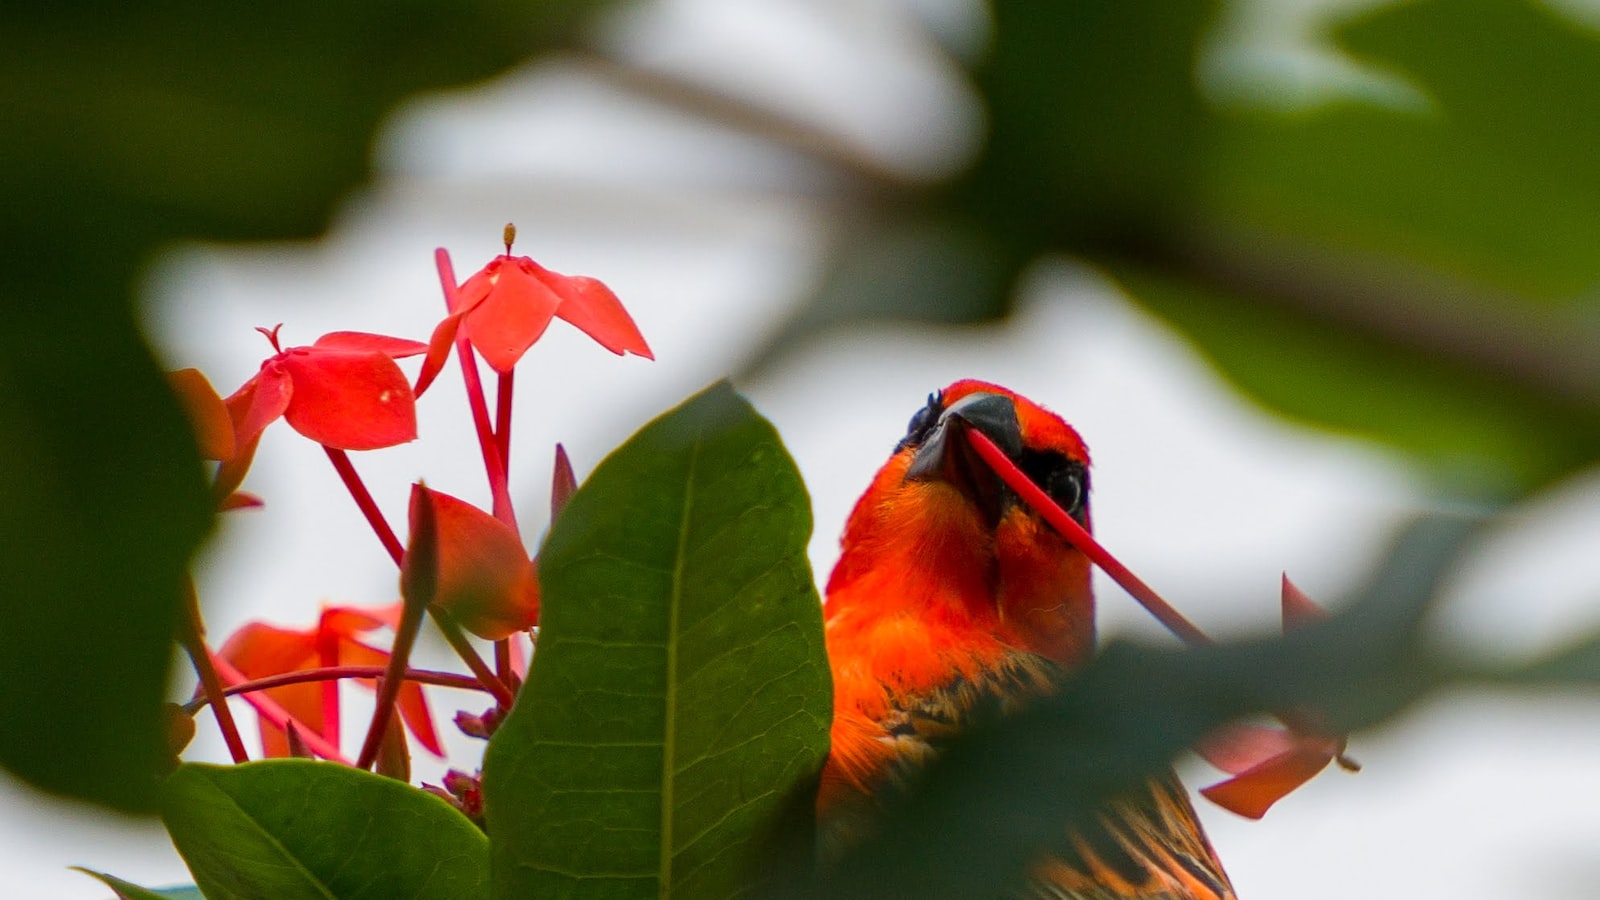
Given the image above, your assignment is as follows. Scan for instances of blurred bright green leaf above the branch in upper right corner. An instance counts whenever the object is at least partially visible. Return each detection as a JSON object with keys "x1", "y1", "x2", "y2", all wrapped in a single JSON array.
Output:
[{"x1": 1203, "y1": 0, "x2": 1600, "y2": 297}]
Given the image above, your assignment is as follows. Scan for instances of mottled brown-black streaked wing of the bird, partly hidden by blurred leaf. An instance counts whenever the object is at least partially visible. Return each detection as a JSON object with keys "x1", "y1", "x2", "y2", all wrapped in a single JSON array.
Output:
[{"x1": 882, "y1": 652, "x2": 1234, "y2": 900}]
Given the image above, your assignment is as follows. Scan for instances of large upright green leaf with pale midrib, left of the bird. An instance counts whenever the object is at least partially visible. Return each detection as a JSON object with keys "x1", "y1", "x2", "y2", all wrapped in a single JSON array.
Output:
[{"x1": 485, "y1": 383, "x2": 832, "y2": 898}]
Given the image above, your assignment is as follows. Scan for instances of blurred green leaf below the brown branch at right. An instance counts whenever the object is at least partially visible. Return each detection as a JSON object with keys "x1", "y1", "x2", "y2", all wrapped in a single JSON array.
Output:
[{"x1": 1107, "y1": 263, "x2": 1600, "y2": 495}]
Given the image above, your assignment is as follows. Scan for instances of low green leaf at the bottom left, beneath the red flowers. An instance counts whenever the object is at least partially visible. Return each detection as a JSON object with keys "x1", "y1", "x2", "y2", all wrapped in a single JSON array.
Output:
[{"x1": 162, "y1": 759, "x2": 490, "y2": 900}]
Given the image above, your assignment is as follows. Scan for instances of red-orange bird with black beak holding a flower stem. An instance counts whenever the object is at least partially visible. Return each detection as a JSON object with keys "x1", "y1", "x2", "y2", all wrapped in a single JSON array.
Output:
[{"x1": 818, "y1": 381, "x2": 1234, "y2": 900}]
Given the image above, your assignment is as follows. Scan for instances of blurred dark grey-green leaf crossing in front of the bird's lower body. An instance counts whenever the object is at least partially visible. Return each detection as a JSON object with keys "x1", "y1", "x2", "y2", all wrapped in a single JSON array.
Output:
[{"x1": 814, "y1": 519, "x2": 1472, "y2": 898}]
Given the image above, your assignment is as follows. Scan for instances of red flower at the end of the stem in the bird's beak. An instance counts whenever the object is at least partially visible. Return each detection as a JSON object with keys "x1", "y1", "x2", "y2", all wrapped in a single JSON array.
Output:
[{"x1": 1195, "y1": 575, "x2": 1354, "y2": 818}]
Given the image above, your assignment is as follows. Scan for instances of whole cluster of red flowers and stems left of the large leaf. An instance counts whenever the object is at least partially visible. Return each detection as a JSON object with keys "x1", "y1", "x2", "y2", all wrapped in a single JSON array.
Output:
[{"x1": 170, "y1": 226, "x2": 653, "y2": 778}]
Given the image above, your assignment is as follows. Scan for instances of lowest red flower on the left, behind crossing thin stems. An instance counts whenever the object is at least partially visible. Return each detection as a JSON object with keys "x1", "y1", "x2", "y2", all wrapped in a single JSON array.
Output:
[{"x1": 218, "y1": 604, "x2": 445, "y2": 756}]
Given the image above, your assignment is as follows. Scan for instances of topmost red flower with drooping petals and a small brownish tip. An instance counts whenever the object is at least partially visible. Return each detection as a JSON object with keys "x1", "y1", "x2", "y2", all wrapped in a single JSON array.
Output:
[{"x1": 416, "y1": 237, "x2": 656, "y2": 387}]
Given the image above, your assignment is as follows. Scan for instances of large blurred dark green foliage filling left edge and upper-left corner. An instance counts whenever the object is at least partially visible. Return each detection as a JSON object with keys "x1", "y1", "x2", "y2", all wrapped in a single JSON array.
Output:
[{"x1": 0, "y1": 0, "x2": 624, "y2": 810}]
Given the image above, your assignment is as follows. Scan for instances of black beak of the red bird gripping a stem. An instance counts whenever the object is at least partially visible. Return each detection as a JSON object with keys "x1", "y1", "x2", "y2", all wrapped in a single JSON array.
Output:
[{"x1": 906, "y1": 394, "x2": 1022, "y2": 525}]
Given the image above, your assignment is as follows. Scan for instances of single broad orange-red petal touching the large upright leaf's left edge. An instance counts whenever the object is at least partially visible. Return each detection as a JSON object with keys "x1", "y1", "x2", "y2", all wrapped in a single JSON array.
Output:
[{"x1": 406, "y1": 485, "x2": 539, "y2": 641}]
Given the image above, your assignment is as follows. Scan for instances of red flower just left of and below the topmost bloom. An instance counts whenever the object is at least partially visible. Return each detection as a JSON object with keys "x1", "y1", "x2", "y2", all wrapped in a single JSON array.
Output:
[{"x1": 227, "y1": 325, "x2": 427, "y2": 450}]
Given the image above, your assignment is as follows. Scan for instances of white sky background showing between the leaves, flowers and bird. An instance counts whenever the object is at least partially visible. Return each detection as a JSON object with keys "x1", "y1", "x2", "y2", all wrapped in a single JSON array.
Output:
[{"x1": 9, "y1": 0, "x2": 1600, "y2": 900}]
